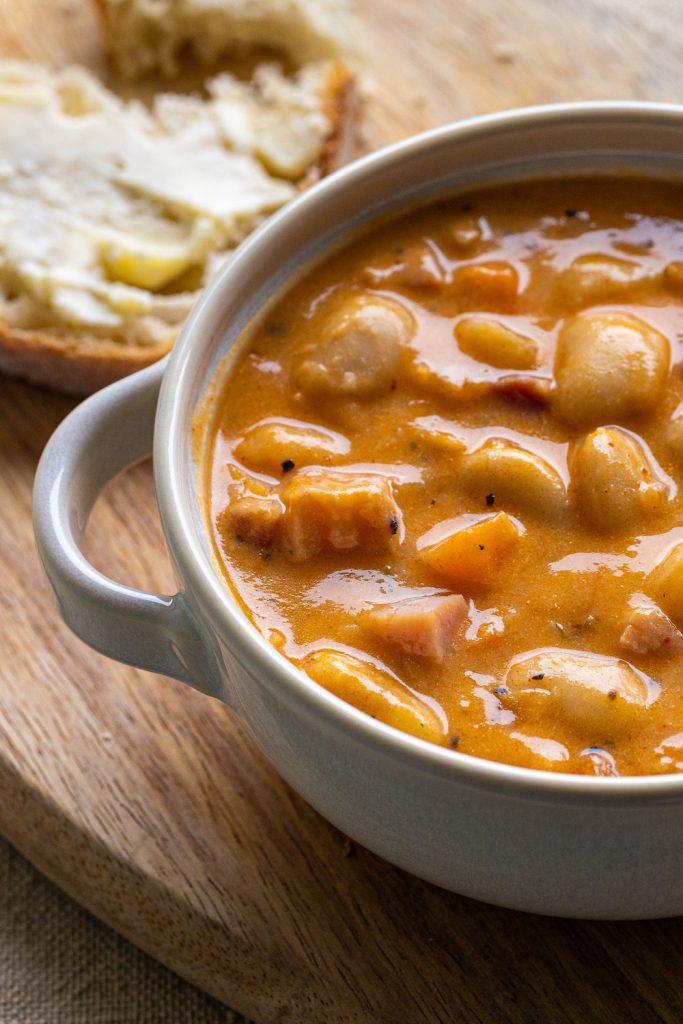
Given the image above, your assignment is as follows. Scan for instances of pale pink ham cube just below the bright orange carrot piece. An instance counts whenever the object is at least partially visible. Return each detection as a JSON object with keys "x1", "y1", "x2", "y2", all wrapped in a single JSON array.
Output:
[{"x1": 362, "y1": 594, "x2": 467, "y2": 662}]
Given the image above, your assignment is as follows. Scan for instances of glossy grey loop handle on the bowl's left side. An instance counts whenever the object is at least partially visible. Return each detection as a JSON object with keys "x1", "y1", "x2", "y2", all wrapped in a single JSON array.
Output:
[{"x1": 33, "y1": 359, "x2": 220, "y2": 695}]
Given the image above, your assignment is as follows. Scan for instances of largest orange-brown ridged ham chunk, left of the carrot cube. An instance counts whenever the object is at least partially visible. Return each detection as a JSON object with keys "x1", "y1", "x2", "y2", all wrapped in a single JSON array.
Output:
[{"x1": 281, "y1": 470, "x2": 403, "y2": 561}]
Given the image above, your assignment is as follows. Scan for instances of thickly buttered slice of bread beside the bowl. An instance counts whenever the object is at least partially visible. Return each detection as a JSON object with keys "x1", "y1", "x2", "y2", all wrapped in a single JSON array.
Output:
[{"x1": 0, "y1": 61, "x2": 352, "y2": 394}]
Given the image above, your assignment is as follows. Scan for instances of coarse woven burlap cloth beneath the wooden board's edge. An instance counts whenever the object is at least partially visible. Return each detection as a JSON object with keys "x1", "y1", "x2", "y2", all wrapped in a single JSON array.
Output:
[{"x1": 0, "y1": 839, "x2": 248, "y2": 1024}]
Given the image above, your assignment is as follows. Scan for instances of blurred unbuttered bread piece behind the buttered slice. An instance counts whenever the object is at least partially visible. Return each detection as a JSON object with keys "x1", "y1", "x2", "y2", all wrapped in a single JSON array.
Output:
[{"x1": 99, "y1": 0, "x2": 358, "y2": 80}]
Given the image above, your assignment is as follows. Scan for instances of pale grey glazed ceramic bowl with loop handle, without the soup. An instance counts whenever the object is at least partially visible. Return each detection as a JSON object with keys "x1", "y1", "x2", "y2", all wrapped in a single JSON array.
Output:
[{"x1": 34, "y1": 103, "x2": 683, "y2": 918}]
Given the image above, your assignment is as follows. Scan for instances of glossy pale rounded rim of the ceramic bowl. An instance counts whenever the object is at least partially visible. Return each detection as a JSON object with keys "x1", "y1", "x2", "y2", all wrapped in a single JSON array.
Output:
[{"x1": 154, "y1": 100, "x2": 683, "y2": 805}]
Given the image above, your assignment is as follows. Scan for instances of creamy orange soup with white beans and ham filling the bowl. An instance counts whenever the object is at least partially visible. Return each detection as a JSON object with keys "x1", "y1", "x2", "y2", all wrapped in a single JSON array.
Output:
[{"x1": 203, "y1": 177, "x2": 683, "y2": 775}]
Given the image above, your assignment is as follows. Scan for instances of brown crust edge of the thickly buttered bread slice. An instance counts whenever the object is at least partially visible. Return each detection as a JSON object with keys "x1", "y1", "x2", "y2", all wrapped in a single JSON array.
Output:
[{"x1": 0, "y1": 63, "x2": 356, "y2": 395}]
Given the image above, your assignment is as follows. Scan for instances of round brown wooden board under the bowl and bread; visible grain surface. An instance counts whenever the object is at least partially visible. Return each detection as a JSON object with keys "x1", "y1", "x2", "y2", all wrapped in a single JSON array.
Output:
[{"x1": 0, "y1": 0, "x2": 683, "y2": 1024}]
